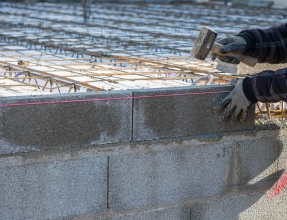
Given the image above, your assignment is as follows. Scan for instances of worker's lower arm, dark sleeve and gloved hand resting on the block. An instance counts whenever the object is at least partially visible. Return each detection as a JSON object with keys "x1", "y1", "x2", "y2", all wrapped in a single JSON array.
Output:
[{"x1": 213, "y1": 68, "x2": 287, "y2": 125}]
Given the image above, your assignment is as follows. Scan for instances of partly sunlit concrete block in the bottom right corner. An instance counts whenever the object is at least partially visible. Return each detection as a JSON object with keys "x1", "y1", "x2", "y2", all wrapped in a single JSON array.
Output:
[{"x1": 191, "y1": 185, "x2": 287, "y2": 220}]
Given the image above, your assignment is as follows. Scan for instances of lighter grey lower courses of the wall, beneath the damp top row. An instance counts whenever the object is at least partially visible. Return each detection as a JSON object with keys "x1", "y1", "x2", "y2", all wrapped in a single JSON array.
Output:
[{"x1": 0, "y1": 130, "x2": 287, "y2": 220}]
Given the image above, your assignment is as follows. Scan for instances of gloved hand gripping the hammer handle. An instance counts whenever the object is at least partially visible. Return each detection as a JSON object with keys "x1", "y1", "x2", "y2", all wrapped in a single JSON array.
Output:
[{"x1": 211, "y1": 36, "x2": 247, "y2": 64}]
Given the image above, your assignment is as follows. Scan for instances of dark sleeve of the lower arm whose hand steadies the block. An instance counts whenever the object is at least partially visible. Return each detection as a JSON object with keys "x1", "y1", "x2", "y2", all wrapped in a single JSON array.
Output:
[{"x1": 243, "y1": 68, "x2": 287, "y2": 103}]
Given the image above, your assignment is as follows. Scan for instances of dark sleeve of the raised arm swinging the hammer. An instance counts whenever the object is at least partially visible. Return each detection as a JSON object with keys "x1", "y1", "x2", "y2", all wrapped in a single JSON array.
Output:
[{"x1": 238, "y1": 23, "x2": 287, "y2": 64}]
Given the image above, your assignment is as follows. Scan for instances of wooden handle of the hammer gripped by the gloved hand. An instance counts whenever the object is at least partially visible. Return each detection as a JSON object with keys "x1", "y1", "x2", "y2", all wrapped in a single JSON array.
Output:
[{"x1": 211, "y1": 42, "x2": 258, "y2": 67}]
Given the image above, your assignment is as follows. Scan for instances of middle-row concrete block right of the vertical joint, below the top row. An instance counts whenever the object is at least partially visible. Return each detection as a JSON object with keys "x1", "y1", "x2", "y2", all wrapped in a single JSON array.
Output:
[{"x1": 109, "y1": 134, "x2": 282, "y2": 211}]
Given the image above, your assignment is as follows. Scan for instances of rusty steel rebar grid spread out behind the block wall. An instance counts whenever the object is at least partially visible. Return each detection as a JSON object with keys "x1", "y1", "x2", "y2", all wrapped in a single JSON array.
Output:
[{"x1": 0, "y1": 3, "x2": 287, "y2": 118}]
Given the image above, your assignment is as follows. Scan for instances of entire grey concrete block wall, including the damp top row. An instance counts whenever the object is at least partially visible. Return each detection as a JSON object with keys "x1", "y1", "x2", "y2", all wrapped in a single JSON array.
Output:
[{"x1": 0, "y1": 86, "x2": 287, "y2": 220}]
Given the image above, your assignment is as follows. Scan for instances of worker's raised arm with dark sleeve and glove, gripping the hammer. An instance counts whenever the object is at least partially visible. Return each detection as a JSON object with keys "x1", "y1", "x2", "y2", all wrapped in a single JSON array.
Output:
[{"x1": 212, "y1": 23, "x2": 287, "y2": 64}]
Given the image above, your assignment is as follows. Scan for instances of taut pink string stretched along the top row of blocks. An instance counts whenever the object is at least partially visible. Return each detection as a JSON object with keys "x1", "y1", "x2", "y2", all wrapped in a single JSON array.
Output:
[{"x1": 0, "y1": 91, "x2": 230, "y2": 107}]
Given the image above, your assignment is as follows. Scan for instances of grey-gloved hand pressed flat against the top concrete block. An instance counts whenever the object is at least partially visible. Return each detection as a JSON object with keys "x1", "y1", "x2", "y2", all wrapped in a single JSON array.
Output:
[{"x1": 213, "y1": 79, "x2": 251, "y2": 125}]
